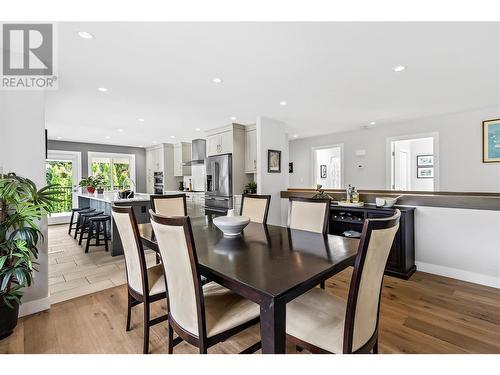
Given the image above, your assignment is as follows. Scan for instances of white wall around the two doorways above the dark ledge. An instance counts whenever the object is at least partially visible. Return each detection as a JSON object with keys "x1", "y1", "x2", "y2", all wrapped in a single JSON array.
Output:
[{"x1": 290, "y1": 107, "x2": 500, "y2": 192}]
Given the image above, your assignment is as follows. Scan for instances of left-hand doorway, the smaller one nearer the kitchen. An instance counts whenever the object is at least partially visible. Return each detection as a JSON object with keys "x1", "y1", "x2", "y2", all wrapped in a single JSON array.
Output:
[{"x1": 313, "y1": 145, "x2": 343, "y2": 189}]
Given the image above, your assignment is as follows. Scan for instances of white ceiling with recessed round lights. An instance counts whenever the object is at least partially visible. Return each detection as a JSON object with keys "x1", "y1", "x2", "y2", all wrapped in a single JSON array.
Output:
[{"x1": 46, "y1": 23, "x2": 500, "y2": 146}]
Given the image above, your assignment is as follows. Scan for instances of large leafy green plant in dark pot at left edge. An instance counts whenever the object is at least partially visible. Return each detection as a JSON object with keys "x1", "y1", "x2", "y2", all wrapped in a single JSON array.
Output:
[{"x1": 0, "y1": 173, "x2": 61, "y2": 339}]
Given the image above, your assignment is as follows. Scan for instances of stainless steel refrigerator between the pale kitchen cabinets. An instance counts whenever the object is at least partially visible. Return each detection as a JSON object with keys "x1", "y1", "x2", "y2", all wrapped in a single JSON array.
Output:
[{"x1": 205, "y1": 154, "x2": 233, "y2": 216}]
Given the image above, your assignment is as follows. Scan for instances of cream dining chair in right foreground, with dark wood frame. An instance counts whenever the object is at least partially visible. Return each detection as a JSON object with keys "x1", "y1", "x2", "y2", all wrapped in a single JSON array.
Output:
[{"x1": 286, "y1": 210, "x2": 400, "y2": 353}]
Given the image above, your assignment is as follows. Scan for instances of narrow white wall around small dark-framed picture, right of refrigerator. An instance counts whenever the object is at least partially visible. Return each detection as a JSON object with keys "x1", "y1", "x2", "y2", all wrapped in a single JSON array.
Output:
[{"x1": 256, "y1": 116, "x2": 288, "y2": 225}]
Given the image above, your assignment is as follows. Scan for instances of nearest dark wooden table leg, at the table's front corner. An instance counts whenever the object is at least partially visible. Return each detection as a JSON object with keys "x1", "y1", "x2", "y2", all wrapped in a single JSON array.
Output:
[{"x1": 260, "y1": 298, "x2": 286, "y2": 354}]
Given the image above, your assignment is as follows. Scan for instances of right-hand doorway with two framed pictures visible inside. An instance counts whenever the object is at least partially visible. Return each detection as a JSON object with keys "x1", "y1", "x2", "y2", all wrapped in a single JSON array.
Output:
[{"x1": 390, "y1": 136, "x2": 438, "y2": 191}]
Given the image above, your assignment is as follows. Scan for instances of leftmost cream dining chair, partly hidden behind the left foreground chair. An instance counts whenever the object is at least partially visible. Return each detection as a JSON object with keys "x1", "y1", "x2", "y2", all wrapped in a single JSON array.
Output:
[{"x1": 112, "y1": 206, "x2": 167, "y2": 354}]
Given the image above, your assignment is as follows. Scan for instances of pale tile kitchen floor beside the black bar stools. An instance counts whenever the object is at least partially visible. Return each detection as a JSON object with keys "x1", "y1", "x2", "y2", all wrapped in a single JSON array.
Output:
[{"x1": 48, "y1": 224, "x2": 155, "y2": 304}]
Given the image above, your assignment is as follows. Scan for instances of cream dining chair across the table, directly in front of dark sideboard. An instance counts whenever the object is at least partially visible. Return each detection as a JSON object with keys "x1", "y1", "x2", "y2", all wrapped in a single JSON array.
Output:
[{"x1": 288, "y1": 198, "x2": 330, "y2": 234}]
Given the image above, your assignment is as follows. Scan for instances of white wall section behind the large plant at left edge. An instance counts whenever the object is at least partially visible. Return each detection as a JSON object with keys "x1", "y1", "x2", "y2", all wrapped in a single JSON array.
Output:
[{"x1": 0, "y1": 91, "x2": 50, "y2": 315}]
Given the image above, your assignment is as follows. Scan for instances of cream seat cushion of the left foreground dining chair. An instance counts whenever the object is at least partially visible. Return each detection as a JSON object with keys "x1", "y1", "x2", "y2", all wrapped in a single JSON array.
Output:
[{"x1": 203, "y1": 282, "x2": 260, "y2": 337}]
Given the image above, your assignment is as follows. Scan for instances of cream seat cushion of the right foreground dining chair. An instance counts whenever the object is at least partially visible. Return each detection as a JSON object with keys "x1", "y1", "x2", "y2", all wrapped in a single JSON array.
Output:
[{"x1": 286, "y1": 288, "x2": 347, "y2": 353}]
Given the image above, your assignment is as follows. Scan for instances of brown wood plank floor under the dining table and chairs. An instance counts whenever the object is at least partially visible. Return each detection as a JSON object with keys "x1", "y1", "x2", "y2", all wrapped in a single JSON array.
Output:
[{"x1": 0, "y1": 269, "x2": 500, "y2": 353}]
